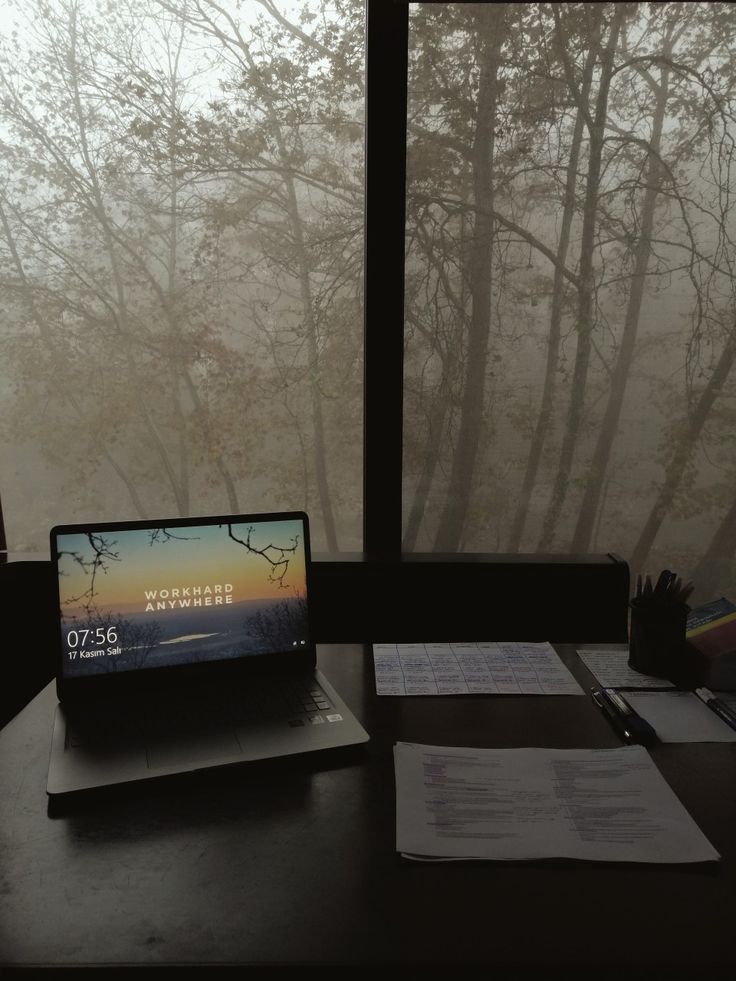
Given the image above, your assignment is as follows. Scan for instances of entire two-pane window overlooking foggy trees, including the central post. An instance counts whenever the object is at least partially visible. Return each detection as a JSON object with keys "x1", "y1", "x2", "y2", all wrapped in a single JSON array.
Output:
[{"x1": 0, "y1": 0, "x2": 736, "y2": 599}]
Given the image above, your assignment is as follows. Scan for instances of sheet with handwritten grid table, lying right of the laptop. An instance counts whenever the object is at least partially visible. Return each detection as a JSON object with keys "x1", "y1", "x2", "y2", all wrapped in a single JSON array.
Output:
[{"x1": 373, "y1": 643, "x2": 584, "y2": 695}]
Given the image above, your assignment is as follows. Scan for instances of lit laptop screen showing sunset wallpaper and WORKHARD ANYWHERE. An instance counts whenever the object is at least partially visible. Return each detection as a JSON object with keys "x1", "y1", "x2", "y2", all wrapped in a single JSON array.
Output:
[{"x1": 51, "y1": 512, "x2": 311, "y2": 682}]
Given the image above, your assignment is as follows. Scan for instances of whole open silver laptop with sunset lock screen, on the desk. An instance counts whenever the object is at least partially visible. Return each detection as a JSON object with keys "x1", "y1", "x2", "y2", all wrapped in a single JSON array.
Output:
[{"x1": 47, "y1": 511, "x2": 368, "y2": 796}]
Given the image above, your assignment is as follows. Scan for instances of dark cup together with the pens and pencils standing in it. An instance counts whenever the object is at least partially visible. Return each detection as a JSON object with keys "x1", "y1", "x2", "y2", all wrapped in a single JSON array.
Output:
[{"x1": 629, "y1": 569, "x2": 698, "y2": 687}]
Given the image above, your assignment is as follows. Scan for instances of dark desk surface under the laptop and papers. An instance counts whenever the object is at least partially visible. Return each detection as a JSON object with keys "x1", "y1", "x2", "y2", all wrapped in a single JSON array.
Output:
[{"x1": 0, "y1": 645, "x2": 736, "y2": 977}]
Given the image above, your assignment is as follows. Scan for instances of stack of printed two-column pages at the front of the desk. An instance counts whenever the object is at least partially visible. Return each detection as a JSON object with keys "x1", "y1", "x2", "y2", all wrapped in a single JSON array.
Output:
[{"x1": 394, "y1": 743, "x2": 720, "y2": 863}]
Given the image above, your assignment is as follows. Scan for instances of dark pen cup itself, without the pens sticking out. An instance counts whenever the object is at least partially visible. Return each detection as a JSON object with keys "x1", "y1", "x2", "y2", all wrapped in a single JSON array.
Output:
[{"x1": 629, "y1": 596, "x2": 702, "y2": 688}]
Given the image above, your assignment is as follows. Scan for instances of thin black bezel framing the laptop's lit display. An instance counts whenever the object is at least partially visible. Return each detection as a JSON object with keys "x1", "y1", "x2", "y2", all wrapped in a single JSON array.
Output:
[{"x1": 49, "y1": 511, "x2": 316, "y2": 701}]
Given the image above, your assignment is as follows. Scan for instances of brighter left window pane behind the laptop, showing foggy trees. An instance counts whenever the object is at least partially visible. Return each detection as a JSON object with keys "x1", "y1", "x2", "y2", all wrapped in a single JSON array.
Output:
[{"x1": 0, "y1": 0, "x2": 364, "y2": 551}]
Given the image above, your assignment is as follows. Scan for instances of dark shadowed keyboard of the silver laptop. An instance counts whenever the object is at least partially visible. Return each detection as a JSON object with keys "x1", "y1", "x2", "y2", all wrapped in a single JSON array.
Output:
[{"x1": 67, "y1": 675, "x2": 334, "y2": 747}]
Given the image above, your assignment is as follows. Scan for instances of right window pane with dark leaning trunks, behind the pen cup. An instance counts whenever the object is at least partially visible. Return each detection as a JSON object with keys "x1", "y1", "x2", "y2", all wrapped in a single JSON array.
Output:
[{"x1": 403, "y1": 3, "x2": 736, "y2": 598}]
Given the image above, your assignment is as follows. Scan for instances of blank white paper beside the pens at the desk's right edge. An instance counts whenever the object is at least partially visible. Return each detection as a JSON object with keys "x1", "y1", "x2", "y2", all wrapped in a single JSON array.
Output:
[{"x1": 626, "y1": 691, "x2": 736, "y2": 743}]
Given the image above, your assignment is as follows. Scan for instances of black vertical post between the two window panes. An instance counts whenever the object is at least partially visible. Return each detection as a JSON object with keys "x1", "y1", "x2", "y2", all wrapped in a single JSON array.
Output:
[{"x1": 363, "y1": 0, "x2": 409, "y2": 556}]
